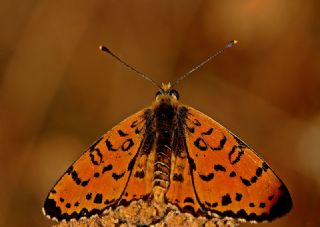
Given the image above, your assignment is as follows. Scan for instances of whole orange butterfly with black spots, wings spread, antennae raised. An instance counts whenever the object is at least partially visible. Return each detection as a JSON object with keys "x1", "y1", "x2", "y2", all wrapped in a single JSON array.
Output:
[{"x1": 44, "y1": 41, "x2": 292, "y2": 222}]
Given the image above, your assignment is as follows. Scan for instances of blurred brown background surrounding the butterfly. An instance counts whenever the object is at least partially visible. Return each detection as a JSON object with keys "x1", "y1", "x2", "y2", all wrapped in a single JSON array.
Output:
[{"x1": 0, "y1": 0, "x2": 320, "y2": 227}]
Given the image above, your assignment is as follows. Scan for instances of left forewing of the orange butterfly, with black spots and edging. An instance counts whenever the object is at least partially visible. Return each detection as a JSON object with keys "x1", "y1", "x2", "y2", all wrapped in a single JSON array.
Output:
[{"x1": 44, "y1": 110, "x2": 151, "y2": 221}]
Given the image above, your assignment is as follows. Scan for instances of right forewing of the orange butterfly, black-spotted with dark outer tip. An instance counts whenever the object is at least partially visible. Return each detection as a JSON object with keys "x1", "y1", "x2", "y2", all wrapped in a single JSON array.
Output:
[{"x1": 181, "y1": 107, "x2": 292, "y2": 222}]
